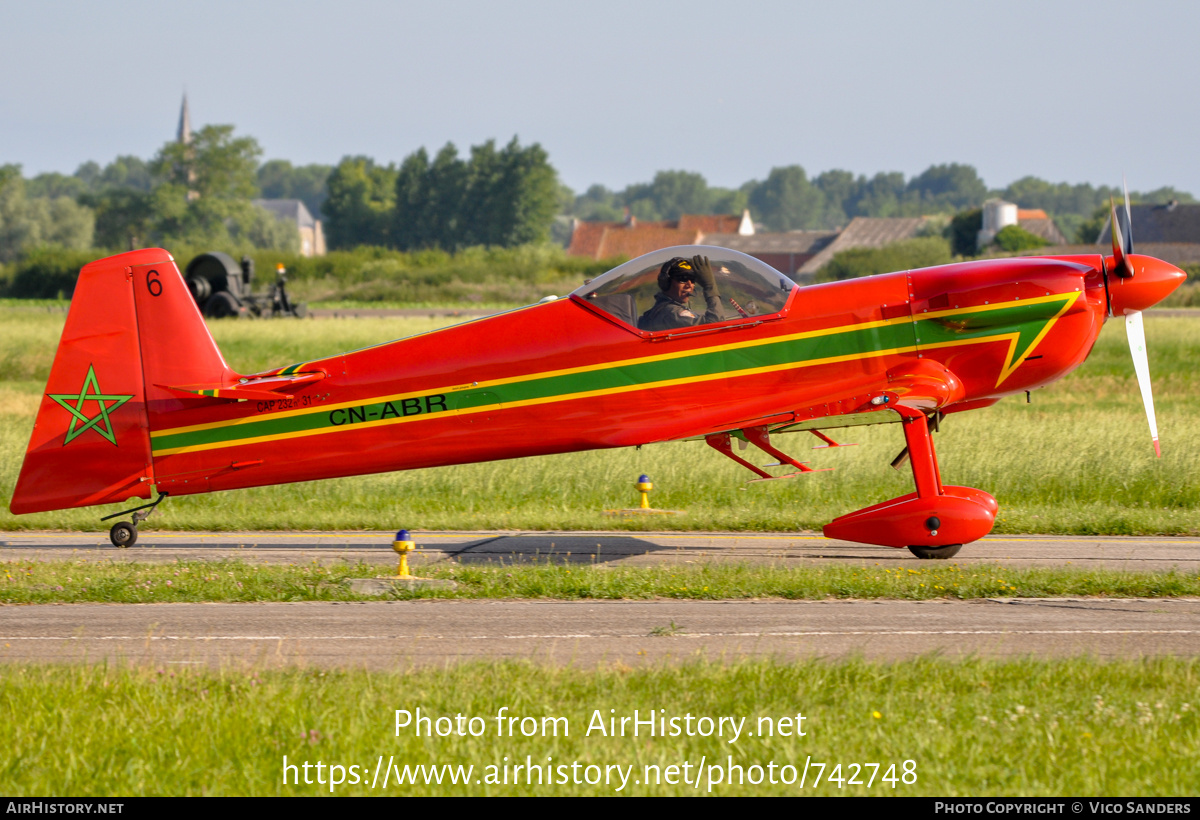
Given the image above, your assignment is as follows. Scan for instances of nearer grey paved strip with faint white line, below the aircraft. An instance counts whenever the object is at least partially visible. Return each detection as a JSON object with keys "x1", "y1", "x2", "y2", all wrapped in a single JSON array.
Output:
[{"x1": 0, "y1": 599, "x2": 1200, "y2": 670}]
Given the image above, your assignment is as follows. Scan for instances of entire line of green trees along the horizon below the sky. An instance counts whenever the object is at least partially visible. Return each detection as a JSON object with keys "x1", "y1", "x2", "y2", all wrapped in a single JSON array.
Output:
[{"x1": 0, "y1": 125, "x2": 1195, "y2": 263}]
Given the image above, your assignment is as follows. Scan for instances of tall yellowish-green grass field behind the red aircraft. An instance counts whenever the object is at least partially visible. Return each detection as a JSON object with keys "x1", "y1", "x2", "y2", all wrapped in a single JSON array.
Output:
[{"x1": 0, "y1": 306, "x2": 1200, "y2": 534}]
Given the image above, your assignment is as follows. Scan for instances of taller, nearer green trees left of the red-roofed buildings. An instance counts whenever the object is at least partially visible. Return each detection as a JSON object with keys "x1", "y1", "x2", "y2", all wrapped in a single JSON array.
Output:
[{"x1": 0, "y1": 125, "x2": 559, "y2": 263}]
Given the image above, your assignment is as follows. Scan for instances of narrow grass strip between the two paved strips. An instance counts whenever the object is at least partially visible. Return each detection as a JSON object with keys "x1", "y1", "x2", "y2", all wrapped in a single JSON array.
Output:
[{"x1": 0, "y1": 559, "x2": 1200, "y2": 604}]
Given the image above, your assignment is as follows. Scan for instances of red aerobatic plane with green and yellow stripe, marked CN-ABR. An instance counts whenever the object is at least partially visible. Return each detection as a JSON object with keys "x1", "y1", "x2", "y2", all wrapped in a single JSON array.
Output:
[{"x1": 10, "y1": 200, "x2": 1184, "y2": 558}]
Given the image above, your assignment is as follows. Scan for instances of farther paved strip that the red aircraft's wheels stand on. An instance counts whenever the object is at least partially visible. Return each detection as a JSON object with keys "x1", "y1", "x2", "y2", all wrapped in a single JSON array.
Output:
[{"x1": 0, "y1": 531, "x2": 1200, "y2": 571}]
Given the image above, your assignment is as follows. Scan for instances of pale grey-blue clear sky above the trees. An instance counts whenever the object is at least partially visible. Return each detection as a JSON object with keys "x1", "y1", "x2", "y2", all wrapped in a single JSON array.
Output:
[{"x1": 0, "y1": 0, "x2": 1200, "y2": 194}]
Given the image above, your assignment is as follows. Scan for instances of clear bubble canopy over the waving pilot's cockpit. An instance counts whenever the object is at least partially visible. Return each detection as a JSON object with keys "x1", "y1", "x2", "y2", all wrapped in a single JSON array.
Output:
[{"x1": 571, "y1": 245, "x2": 797, "y2": 328}]
